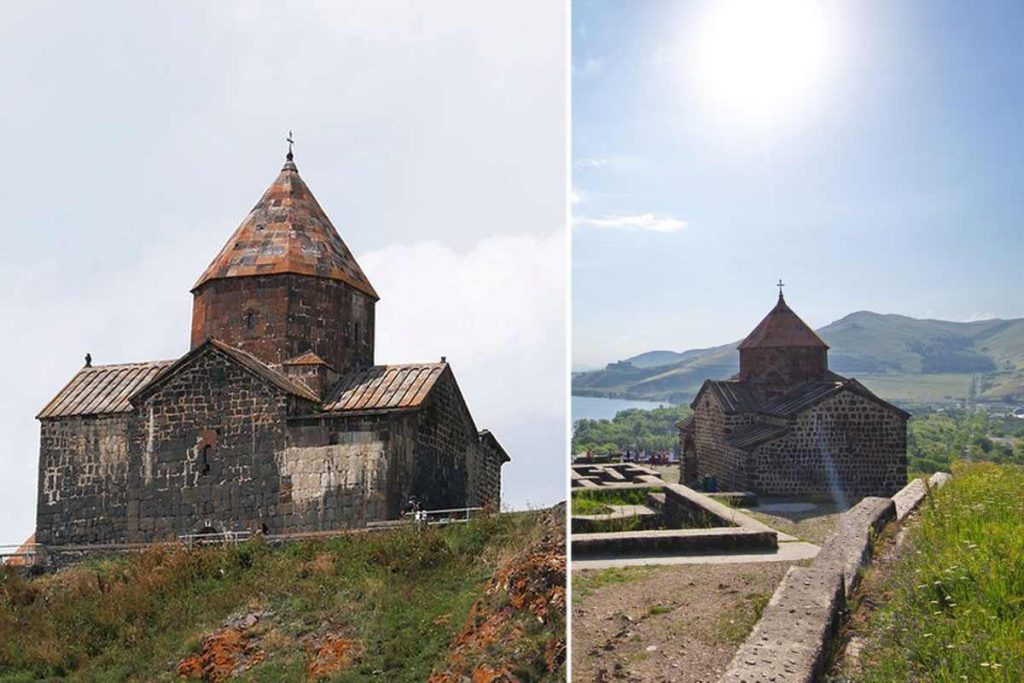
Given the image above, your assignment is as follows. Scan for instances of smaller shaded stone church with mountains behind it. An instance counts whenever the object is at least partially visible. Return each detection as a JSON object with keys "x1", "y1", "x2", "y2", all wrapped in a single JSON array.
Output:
[{"x1": 677, "y1": 289, "x2": 909, "y2": 501}]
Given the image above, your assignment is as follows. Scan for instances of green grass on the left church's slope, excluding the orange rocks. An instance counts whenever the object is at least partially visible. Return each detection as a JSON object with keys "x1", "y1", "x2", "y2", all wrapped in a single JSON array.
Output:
[{"x1": 0, "y1": 513, "x2": 561, "y2": 681}]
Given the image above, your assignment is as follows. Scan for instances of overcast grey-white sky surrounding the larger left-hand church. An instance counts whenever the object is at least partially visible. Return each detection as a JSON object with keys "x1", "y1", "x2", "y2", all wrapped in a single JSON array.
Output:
[{"x1": 0, "y1": 0, "x2": 567, "y2": 543}]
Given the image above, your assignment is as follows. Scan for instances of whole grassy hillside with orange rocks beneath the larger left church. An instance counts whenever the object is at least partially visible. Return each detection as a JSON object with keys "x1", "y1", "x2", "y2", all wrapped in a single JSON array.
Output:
[{"x1": 0, "y1": 507, "x2": 565, "y2": 683}]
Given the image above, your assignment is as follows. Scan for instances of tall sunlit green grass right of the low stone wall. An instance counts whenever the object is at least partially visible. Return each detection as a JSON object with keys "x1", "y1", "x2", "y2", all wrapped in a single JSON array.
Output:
[{"x1": 861, "y1": 463, "x2": 1024, "y2": 683}]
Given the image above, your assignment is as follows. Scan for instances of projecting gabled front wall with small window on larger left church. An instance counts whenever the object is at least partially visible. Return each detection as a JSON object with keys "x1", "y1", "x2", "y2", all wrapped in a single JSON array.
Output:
[{"x1": 127, "y1": 347, "x2": 296, "y2": 541}]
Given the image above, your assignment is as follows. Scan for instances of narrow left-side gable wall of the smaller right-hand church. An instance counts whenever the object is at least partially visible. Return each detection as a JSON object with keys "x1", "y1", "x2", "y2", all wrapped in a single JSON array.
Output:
[{"x1": 692, "y1": 391, "x2": 746, "y2": 490}]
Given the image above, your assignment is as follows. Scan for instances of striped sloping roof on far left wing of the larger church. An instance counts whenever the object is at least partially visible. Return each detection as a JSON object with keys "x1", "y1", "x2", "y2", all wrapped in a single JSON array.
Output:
[{"x1": 36, "y1": 360, "x2": 174, "y2": 419}]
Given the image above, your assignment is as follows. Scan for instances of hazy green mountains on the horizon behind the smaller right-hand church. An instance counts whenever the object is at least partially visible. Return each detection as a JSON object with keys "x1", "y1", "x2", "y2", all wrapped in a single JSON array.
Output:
[{"x1": 572, "y1": 310, "x2": 1024, "y2": 403}]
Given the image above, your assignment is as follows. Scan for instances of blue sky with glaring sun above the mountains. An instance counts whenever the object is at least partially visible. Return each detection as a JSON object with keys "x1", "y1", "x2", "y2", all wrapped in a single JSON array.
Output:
[{"x1": 572, "y1": 0, "x2": 1024, "y2": 368}]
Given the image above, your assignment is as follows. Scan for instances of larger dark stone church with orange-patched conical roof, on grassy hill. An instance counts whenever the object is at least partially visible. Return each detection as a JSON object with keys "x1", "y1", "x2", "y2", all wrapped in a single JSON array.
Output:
[{"x1": 36, "y1": 151, "x2": 509, "y2": 545}]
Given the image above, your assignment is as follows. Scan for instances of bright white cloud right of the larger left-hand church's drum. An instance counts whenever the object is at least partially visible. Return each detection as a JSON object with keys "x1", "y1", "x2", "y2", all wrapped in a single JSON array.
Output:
[{"x1": 359, "y1": 230, "x2": 567, "y2": 508}]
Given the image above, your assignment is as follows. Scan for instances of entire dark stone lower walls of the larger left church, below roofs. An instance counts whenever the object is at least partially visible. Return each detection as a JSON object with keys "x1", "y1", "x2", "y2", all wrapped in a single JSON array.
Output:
[{"x1": 37, "y1": 346, "x2": 502, "y2": 545}]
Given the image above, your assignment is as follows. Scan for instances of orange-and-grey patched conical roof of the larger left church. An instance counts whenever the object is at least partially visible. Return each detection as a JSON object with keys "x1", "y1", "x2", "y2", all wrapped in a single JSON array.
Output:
[{"x1": 193, "y1": 160, "x2": 379, "y2": 299}]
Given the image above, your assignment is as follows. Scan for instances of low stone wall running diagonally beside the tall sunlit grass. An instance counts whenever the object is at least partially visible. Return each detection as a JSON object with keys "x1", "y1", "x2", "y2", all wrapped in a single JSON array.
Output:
[{"x1": 720, "y1": 472, "x2": 949, "y2": 683}]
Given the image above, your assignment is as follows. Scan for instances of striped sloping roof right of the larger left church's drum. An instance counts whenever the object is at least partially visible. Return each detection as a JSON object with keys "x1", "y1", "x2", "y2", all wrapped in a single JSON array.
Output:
[{"x1": 324, "y1": 362, "x2": 447, "y2": 413}]
